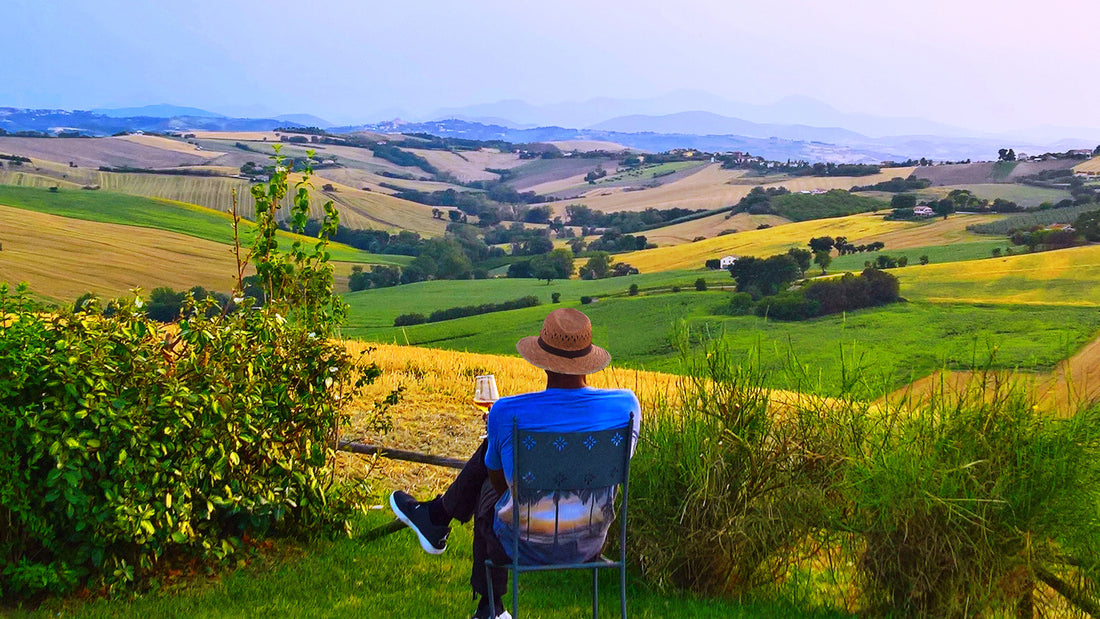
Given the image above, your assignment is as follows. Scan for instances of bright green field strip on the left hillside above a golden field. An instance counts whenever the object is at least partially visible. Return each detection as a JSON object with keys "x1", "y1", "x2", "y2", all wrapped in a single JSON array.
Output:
[{"x1": 0, "y1": 185, "x2": 411, "y2": 265}]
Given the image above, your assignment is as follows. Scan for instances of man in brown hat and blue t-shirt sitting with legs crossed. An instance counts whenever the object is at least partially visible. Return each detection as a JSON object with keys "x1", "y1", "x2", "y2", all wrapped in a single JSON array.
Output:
[{"x1": 389, "y1": 309, "x2": 641, "y2": 619}]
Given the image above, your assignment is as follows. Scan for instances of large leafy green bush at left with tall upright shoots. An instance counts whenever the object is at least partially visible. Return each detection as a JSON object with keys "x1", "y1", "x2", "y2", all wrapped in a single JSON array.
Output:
[{"x1": 0, "y1": 147, "x2": 377, "y2": 598}]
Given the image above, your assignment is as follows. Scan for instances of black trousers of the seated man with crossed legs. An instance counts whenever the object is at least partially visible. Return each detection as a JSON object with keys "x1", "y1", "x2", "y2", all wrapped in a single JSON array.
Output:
[{"x1": 443, "y1": 441, "x2": 512, "y2": 597}]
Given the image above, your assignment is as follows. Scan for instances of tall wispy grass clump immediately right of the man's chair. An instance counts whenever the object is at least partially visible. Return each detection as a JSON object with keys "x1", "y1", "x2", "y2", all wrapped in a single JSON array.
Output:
[{"x1": 630, "y1": 344, "x2": 846, "y2": 596}]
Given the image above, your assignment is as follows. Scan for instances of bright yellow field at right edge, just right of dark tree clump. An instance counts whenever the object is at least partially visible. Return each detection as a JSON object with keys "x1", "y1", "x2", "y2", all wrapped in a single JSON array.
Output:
[{"x1": 897, "y1": 245, "x2": 1100, "y2": 307}]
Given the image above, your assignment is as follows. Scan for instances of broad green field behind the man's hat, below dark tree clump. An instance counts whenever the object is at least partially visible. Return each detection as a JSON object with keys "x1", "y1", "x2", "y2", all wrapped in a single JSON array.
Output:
[{"x1": 344, "y1": 290, "x2": 1100, "y2": 394}]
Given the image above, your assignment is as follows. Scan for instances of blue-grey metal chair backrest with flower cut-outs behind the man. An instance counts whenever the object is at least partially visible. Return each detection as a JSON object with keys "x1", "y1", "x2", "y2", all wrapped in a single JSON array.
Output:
[{"x1": 512, "y1": 414, "x2": 634, "y2": 556}]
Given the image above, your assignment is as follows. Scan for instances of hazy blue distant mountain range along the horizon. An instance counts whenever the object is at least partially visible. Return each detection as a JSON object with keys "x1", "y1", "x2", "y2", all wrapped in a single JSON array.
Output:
[{"x1": 0, "y1": 91, "x2": 1100, "y2": 163}]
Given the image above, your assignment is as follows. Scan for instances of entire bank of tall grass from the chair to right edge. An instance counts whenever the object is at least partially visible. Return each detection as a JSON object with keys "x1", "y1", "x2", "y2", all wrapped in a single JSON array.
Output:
[{"x1": 629, "y1": 343, "x2": 1100, "y2": 617}]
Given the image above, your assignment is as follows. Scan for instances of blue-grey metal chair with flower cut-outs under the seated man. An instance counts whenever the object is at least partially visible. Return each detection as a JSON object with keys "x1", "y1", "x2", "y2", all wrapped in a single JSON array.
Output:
[{"x1": 485, "y1": 414, "x2": 634, "y2": 619}]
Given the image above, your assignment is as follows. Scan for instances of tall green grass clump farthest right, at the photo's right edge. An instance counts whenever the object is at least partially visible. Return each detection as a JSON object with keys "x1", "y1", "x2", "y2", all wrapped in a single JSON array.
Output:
[{"x1": 828, "y1": 373, "x2": 1100, "y2": 617}]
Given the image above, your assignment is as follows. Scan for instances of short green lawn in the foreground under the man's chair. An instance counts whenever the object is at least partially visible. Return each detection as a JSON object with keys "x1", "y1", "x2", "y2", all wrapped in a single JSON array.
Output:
[{"x1": 0, "y1": 512, "x2": 851, "y2": 619}]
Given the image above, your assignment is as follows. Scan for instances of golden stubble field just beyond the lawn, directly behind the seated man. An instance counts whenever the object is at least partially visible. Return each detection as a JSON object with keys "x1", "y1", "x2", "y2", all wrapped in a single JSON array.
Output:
[{"x1": 340, "y1": 341, "x2": 818, "y2": 494}]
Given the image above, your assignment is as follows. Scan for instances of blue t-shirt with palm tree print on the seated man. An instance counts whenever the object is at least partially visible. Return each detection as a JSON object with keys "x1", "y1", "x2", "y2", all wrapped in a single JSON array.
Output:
[{"x1": 485, "y1": 387, "x2": 641, "y2": 563}]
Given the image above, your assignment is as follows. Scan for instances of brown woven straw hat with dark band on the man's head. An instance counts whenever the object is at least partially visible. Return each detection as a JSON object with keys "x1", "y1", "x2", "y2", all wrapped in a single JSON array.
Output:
[{"x1": 516, "y1": 308, "x2": 612, "y2": 374}]
